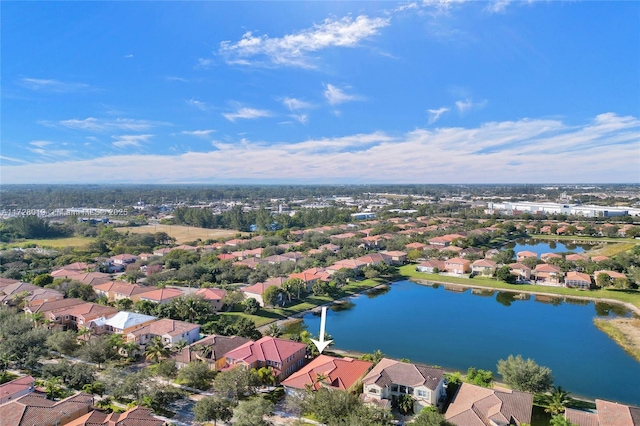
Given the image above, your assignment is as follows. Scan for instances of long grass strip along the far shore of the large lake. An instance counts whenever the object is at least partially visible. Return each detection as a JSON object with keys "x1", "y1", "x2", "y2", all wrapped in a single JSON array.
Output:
[{"x1": 400, "y1": 264, "x2": 640, "y2": 308}]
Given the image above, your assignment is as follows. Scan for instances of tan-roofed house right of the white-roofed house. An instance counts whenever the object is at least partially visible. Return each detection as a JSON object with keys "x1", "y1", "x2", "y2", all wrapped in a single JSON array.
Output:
[{"x1": 127, "y1": 318, "x2": 200, "y2": 347}]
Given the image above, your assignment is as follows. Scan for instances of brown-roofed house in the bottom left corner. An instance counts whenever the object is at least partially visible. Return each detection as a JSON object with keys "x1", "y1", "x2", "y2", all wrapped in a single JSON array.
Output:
[{"x1": 0, "y1": 392, "x2": 93, "y2": 426}]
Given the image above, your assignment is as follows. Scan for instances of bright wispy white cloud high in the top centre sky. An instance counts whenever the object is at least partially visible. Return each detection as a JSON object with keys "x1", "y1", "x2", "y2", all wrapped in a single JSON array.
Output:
[{"x1": 219, "y1": 15, "x2": 389, "y2": 68}]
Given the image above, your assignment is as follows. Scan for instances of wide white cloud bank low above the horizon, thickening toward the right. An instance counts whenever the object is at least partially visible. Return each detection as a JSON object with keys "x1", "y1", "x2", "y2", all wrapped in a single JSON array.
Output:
[{"x1": 0, "y1": 113, "x2": 640, "y2": 183}]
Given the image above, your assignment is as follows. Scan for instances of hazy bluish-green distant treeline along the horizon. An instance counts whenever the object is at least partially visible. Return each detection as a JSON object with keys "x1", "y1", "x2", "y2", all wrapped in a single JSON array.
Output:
[{"x1": 0, "y1": 184, "x2": 637, "y2": 209}]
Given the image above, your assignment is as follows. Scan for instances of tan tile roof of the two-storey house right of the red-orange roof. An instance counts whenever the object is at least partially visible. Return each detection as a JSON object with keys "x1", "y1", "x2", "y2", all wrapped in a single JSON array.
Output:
[{"x1": 362, "y1": 358, "x2": 444, "y2": 390}]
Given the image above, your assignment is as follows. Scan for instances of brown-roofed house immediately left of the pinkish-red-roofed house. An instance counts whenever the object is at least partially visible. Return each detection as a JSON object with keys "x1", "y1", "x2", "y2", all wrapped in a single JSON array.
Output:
[{"x1": 173, "y1": 335, "x2": 251, "y2": 371}]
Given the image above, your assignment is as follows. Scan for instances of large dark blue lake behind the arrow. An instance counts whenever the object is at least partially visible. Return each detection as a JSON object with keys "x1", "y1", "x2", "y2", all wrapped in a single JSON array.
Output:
[{"x1": 304, "y1": 281, "x2": 640, "y2": 405}]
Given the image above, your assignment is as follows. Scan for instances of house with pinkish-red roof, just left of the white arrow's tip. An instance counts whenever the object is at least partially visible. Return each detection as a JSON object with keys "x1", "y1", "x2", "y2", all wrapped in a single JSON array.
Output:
[{"x1": 225, "y1": 336, "x2": 307, "y2": 381}]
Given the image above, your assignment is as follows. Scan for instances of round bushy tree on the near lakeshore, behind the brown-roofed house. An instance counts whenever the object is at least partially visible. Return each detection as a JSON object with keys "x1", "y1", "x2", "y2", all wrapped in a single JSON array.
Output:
[{"x1": 498, "y1": 355, "x2": 553, "y2": 393}]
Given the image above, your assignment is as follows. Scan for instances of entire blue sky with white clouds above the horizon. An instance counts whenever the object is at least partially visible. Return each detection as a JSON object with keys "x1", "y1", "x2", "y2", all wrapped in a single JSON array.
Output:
[{"x1": 0, "y1": 0, "x2": 640, "y2": 184}]
